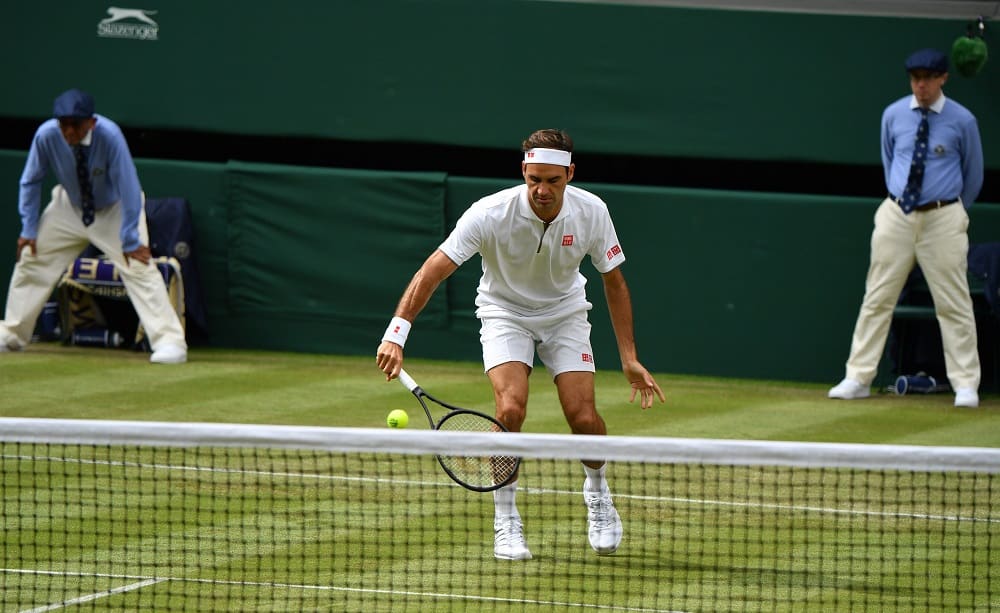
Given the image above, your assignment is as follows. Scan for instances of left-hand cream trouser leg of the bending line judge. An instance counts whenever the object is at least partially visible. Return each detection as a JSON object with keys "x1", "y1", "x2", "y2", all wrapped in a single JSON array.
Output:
[{"x1": 0, "y1": 185, "x2": 87, "y2": 351}]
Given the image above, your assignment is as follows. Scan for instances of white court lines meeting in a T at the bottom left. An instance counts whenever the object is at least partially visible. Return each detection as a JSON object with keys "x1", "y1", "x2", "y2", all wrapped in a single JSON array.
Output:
[{"x1": 0, "y1": 568, "x2": 685, "y2": 613}]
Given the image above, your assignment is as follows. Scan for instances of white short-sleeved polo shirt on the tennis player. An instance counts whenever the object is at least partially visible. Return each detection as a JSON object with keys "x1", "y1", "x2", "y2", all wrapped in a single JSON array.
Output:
[{"x1": 439, "y1": 185, "x2": 625, "y2": 317}]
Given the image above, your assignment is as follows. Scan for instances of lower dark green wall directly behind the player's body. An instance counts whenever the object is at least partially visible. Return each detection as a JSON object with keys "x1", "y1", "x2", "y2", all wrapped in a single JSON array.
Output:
[{"x1": 0, "y1": 151, "x2": 1000, "y2": 382}]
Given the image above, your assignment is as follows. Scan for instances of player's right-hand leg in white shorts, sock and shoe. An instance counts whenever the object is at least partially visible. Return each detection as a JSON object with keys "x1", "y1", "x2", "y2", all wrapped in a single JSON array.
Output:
[{"x1": 538, "y1": 312, "x2": 624, "y2": 555}]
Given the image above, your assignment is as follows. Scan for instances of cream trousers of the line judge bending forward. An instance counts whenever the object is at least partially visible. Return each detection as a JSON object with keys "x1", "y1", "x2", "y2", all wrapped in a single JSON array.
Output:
[{"x1": 0, "y1": 185, "x2": 187, "y2": 350}]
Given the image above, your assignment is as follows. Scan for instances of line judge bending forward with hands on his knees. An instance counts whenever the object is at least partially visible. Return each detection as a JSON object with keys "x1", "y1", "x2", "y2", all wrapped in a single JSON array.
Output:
[{"x1": 0, "y1": 89, "x2": 187, "y2": 364}]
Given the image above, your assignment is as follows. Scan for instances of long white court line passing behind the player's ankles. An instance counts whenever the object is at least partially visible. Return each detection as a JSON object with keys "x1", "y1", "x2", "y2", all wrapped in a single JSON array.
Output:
[{"x1": 7, "y1": 455, "x2": 1000, "y2": 523}]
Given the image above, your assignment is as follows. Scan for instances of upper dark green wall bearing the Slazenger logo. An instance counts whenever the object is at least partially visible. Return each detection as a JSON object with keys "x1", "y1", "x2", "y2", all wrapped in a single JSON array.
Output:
[{"x1": 0, "y1": 0, "x2": 1000, "y2": 167}]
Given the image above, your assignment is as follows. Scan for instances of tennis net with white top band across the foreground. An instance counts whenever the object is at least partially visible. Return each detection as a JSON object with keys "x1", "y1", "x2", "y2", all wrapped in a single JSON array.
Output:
[{"x1": 0, "y1": 418, "x2": 1000, "y2": 612}]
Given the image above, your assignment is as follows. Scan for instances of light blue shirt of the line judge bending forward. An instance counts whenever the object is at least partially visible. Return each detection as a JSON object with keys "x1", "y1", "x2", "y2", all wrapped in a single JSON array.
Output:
[{"x1": 18, "y1": 114, "x2": 142, "y2": 253}]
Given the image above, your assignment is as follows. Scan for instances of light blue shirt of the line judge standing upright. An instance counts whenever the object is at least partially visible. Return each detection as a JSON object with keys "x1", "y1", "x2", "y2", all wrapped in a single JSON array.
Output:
[{"x1": 882, "y1": 94, "x2": 983, "y2": 208}]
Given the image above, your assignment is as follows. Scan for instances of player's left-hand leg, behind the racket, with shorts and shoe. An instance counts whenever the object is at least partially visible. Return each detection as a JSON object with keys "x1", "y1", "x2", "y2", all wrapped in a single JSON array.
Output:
[{"x1": 480, "y1": 318, "x2": 535, "y2": 560}]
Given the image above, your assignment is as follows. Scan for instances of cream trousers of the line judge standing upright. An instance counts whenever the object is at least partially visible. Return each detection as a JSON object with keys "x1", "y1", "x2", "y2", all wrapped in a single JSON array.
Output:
[{"x1": 847, "y1": 198, "x2": 980, "y2": 390}]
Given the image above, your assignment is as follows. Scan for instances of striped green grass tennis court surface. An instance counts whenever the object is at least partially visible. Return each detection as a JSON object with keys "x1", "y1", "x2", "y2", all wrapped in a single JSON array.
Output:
[{"x1": 0, "y1": 344, "x2": 1000, "y2": 613}]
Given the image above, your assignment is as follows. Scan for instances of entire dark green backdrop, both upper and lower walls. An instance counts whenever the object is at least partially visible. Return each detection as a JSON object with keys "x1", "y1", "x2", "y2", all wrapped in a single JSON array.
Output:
[{"x1": 0, "y1": 0, "x2": 1000, "y2": 381}]
